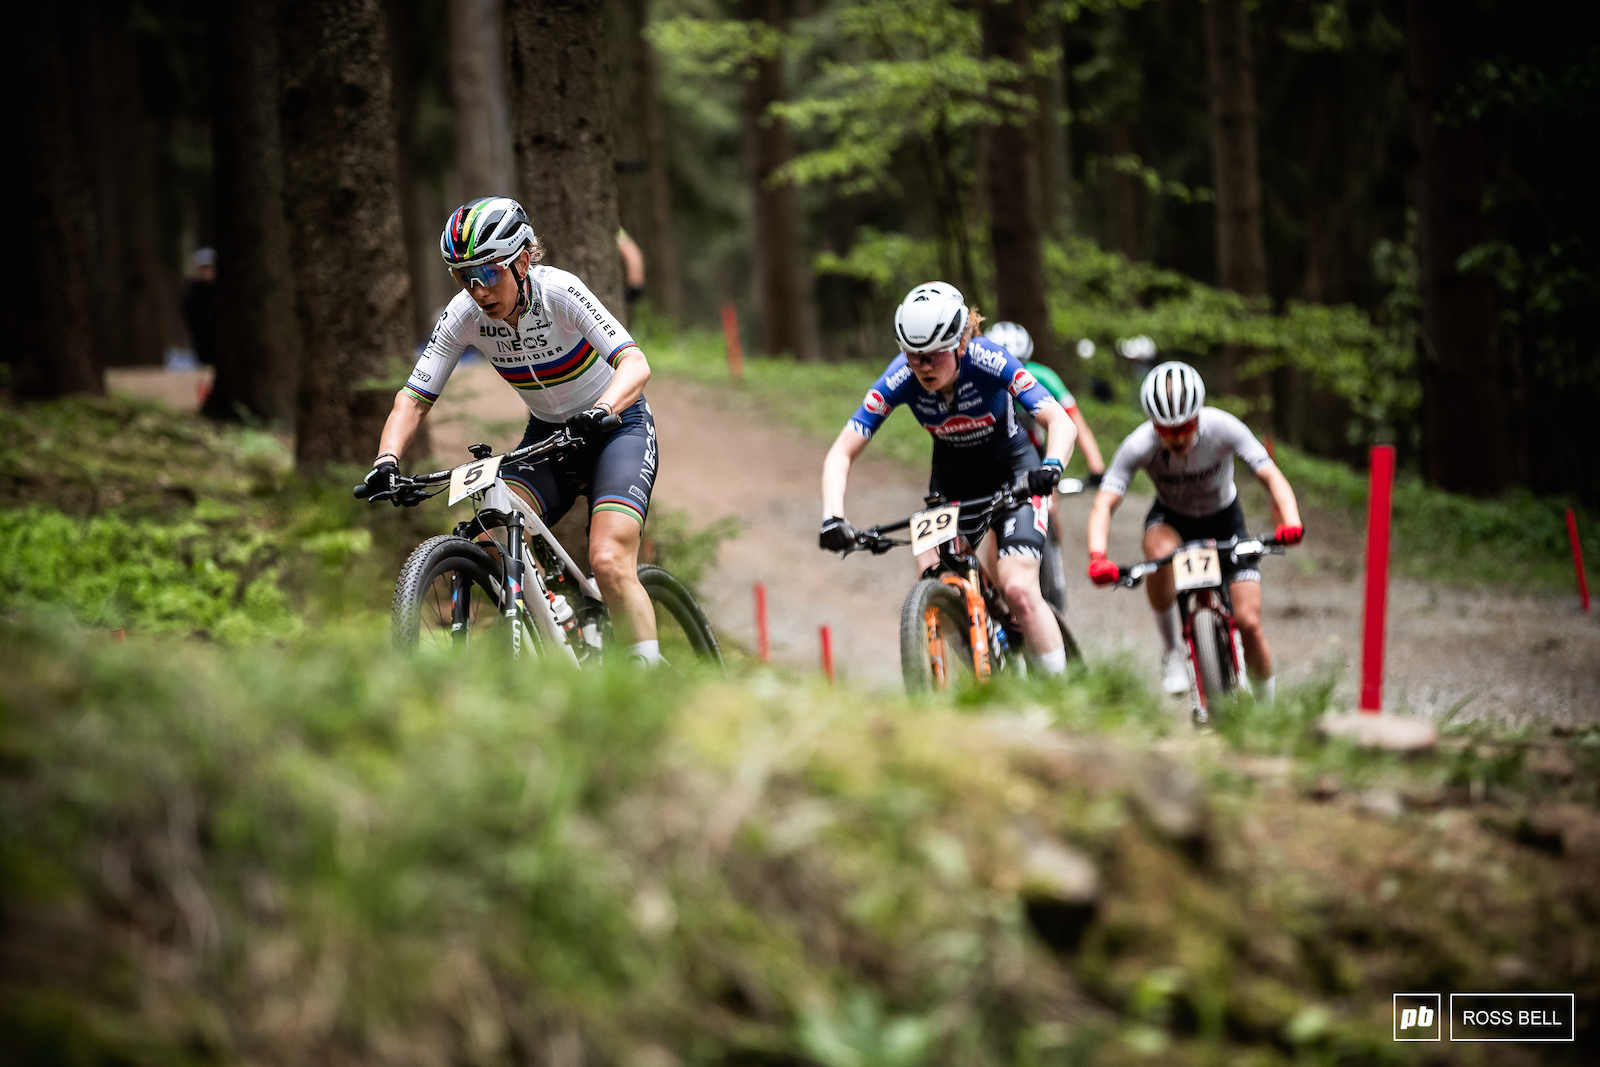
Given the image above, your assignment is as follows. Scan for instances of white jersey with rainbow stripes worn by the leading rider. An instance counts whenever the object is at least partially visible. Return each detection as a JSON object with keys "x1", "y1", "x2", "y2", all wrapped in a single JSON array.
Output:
[{"x1": 403, "y1": 266, "x2": 638, "y2": 422}]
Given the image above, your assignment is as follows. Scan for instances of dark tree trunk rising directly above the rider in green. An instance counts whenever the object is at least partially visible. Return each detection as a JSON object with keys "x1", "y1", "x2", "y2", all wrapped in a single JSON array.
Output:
[{"x1": 979, "y1": 0, "x2": 1054, "y2": 365}]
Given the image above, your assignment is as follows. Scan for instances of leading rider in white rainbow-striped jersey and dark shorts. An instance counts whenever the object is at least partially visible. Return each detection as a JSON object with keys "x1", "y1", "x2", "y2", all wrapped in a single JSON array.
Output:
[{"x1": 363, "y1": 197, "x2": 661, "y2": 665}]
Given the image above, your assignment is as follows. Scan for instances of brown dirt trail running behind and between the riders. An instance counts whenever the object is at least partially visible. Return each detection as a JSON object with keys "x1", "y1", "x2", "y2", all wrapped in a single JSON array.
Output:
[{"x1": 112, "y1": 363, "x2": 1600, "y2": 721}]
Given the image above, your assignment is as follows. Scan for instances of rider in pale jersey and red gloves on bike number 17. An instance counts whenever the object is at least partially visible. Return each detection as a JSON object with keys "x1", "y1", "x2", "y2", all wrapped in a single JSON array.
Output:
[{"x1": 1088, "y1": 362, "x2": 1304, "y2": 701}]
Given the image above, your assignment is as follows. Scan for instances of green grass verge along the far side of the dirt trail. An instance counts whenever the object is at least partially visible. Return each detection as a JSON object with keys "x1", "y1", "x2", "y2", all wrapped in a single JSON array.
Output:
[{"x1": 640, "y1": 320, "x2": 1600, "y2": 592}]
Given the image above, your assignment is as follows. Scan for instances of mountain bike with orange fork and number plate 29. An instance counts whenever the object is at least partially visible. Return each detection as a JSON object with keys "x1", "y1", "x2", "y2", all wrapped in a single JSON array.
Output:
[{"x1": 842, "y1": 475, "x2": 1083, "y2": 693}]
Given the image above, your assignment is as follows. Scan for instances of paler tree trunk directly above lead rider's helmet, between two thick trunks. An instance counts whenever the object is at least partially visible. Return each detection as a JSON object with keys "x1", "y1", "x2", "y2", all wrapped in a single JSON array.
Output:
[{"x1": 451, "y1": 0, "x2": 515, "y2": 199}]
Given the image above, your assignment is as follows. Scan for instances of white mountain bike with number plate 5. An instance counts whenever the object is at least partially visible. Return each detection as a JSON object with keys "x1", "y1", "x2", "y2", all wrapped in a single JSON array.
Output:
[{"x1": 355, "y1": 416, "x2": 722, "y2": 667}]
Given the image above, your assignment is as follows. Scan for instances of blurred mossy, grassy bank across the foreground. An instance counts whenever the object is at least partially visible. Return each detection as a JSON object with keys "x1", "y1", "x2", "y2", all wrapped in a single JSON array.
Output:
[{"x1": 0, "y1": 616, "x2": 1600, "y2": 1067}]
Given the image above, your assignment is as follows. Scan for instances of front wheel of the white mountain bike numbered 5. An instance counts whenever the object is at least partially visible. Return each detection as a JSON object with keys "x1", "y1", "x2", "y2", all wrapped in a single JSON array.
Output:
[{"x1": 389, "y1": 534, "x2": 506, "y2": 651}]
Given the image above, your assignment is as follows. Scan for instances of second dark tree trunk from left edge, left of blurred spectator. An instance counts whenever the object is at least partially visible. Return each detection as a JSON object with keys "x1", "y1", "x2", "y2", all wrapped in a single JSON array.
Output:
[{"x1": 75, "y1": 6, "x2": 182, "y2": 366}]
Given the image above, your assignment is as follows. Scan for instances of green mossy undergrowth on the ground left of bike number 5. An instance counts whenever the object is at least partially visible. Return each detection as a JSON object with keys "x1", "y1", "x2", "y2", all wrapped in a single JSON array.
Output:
[{"x1": 0, "y1": 398, "x2": 736, "y2": 641}]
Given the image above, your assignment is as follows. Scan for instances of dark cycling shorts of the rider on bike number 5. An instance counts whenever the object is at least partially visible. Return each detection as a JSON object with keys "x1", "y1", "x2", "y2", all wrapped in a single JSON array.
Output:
[{"x1": 501, "y1": 397, "x2": 656, "y2": 526}]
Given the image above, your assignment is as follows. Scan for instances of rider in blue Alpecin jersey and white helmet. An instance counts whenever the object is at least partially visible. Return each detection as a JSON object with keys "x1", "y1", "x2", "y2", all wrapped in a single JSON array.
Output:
[{"x1": 818, "y1": 282, "x2": 1077, "y2": 673}]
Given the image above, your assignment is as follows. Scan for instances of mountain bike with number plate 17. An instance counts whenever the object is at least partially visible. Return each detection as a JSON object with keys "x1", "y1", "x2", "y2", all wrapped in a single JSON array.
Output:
[{"x1": 1117, "y1": 537, "x2": 1283, "y2": 726}]
